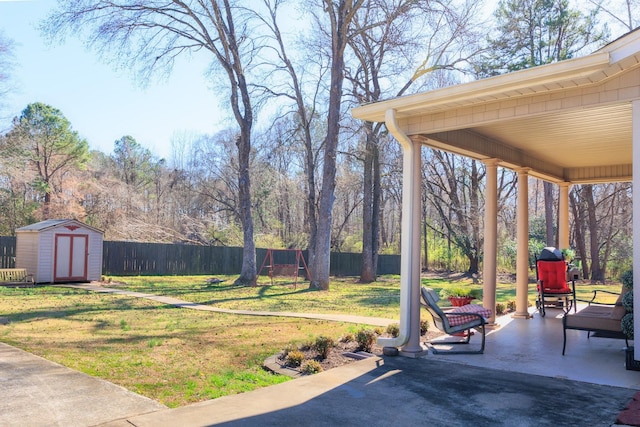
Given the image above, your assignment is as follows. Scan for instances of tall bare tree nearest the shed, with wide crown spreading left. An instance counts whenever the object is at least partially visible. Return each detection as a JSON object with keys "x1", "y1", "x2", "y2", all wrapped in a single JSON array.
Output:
[{"x1": 43, "y1": 0, "x2": 259, "y2": 284}]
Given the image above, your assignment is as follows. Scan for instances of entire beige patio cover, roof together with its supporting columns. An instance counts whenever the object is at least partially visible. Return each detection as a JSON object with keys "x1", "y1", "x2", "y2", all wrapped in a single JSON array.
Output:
[{"x1": 352, "y1": 30, "x2": 640, "y2": 356}]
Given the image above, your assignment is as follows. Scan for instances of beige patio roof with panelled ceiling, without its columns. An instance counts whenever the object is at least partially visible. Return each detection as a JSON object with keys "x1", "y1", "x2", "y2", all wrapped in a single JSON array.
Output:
[{"x1": 352, "y1": 31, "x2": 640, "y2": 184}]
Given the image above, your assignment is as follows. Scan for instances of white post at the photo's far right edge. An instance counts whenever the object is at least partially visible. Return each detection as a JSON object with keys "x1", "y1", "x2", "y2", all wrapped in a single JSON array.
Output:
[{"x1": 631, "y1": 101, "x2": 640, "y2": 360}]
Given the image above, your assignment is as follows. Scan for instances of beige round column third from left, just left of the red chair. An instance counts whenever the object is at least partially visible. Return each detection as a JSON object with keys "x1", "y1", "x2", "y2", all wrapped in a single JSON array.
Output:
[{"x1": 512, "y1": 168, "x2": 531, "y2": 319}]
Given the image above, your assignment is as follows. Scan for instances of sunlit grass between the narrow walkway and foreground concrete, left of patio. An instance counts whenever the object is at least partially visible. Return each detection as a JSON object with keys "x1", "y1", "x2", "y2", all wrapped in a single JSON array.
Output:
[{"x1": 0, "y1": 287, "x2": 359, "y2": 407}]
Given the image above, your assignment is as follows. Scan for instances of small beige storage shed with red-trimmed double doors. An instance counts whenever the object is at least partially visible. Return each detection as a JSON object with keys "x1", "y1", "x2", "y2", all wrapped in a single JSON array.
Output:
[{"x1": 16, "y1": 219, "x2": 104, "y2": 283}]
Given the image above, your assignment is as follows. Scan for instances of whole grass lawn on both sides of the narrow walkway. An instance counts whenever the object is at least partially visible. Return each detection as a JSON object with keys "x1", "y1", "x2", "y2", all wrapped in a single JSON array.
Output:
[{"x1": 0, "y1": 276, "x2": 620, "y2": 407}]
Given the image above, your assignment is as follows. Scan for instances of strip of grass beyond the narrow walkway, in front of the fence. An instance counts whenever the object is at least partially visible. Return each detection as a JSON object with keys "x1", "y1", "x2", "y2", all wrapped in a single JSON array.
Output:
[{"x1": 104, "y1": 275, "x2": 620, "y2": 312}]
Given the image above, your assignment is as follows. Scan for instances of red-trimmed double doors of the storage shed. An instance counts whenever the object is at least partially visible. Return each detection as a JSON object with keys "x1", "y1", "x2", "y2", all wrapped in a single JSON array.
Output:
[{"x1": 53, "y1": 234, "x2": 89, "y2": 282}]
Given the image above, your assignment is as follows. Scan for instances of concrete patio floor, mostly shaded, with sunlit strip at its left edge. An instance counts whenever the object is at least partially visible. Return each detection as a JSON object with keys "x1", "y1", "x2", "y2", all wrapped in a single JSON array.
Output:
[{"x1": 95, "y1": 309, "x2": 640, "y2": 427}]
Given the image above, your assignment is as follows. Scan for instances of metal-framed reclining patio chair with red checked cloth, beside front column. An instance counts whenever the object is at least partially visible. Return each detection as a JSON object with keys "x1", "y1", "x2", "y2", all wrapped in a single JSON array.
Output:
[{"x1": 421, "y1": 286, "x2": 491, "y2": 354}]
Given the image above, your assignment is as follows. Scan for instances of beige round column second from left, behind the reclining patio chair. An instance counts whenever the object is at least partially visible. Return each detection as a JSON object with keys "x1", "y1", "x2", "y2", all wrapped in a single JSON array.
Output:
[{"x1": 482, "y1": 159, "x2": 499, "y2": 323}]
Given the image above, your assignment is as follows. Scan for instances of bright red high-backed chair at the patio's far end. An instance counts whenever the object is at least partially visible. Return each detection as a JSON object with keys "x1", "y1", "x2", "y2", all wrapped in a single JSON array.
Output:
[{"x1": 536, "y1": 259, "x2": 577, "y2": 317}]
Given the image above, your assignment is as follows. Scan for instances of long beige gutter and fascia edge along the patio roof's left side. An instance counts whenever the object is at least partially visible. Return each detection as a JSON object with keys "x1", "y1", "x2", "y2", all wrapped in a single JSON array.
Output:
[{"x1": 351, "y1": 52, "x2": 610, "y2": 122}]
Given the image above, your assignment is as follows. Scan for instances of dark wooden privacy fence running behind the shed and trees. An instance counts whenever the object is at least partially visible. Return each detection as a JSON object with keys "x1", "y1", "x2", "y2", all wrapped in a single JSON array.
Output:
[{"x1": 0, "y1": 236, "x2": 400, "y2": 276}]
